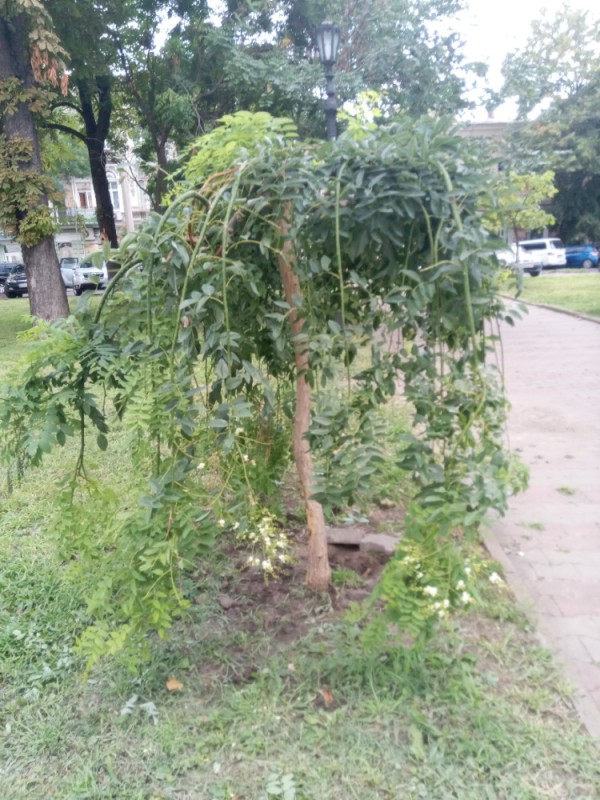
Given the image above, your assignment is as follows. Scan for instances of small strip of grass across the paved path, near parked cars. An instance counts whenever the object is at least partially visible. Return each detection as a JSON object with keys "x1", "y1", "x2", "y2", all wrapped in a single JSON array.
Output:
[{"x1": 510, "y1": 270, "x2": 600, "y2": 318}]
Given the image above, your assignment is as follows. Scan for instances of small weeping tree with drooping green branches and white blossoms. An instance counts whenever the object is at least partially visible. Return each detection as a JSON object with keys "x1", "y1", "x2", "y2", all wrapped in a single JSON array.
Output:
[{"x1": 1, "y1": 113, "x2": 516, "y2": 661}]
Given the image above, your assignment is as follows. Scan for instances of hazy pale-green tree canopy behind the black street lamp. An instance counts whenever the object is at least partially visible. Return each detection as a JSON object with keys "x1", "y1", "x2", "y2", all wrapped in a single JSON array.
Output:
[{"x1": 204, "y1": 0, "x2": 482, "y2": 124}]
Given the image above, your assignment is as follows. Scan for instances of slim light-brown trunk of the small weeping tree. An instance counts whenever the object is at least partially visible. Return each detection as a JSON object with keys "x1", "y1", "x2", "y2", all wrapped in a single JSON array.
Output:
[{"x1": 279, "y1": 220, "x2": 331, "y2": 592}]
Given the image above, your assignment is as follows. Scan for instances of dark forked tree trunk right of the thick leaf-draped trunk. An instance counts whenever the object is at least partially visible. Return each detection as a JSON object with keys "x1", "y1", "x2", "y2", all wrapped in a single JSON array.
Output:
[{"x1": 77, "y1": 77, "x2": 119, "y2": 247}]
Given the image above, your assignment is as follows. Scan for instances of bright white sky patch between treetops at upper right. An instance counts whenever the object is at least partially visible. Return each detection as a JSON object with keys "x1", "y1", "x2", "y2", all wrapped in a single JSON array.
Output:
[{"x1": 459, "y1": 0, "x2": 600, "y2": 120}]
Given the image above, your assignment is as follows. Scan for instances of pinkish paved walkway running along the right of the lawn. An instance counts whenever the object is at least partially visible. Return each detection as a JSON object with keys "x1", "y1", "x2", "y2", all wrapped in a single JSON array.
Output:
[{"x1": 486, "y1": 304, "x2": 600, "y2": 738}]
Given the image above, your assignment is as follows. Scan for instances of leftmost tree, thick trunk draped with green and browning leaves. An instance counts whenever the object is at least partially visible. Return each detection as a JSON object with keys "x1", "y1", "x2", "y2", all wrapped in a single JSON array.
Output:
[{"x1": 0, "y1": 0, "x2": 69, "y2": 319}]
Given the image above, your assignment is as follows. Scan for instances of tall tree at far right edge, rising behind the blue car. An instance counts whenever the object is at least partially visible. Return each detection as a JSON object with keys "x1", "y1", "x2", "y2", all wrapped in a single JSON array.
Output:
[{"x1": 502, "y1": 7, "x2": 600, "y2": 242}]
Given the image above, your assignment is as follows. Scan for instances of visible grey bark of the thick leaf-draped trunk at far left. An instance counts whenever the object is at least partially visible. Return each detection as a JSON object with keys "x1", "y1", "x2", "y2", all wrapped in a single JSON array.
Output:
[{"x1": 0, "y1": 14, "x2": 69, "y2": 320}]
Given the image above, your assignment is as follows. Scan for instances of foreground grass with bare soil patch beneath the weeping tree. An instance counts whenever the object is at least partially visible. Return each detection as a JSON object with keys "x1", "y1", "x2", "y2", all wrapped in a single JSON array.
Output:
[{"x1": 0, "y1": 296, "x2": 600, "y2": 800}]
